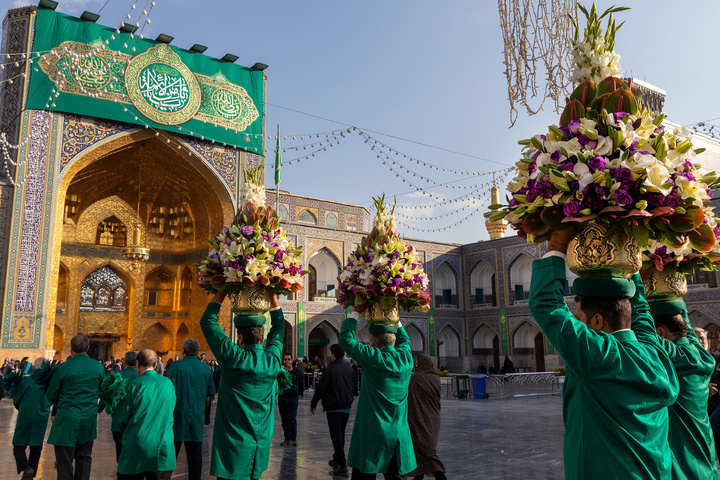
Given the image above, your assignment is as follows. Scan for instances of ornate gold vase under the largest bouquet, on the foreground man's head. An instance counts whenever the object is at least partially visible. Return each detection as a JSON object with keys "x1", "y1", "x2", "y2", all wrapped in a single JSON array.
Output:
[{"x1": 568, "y1": 222, "x2": 642, "y2": 278}]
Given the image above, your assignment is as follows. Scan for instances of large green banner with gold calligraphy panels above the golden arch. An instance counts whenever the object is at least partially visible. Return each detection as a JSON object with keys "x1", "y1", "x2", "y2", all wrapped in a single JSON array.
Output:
[{"x1": 26, "y1": 8, "x2": 265, "y2": 154}]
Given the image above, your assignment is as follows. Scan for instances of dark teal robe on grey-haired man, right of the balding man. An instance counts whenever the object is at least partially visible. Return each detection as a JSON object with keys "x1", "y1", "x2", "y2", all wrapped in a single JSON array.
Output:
[{"x1": 167, "y1": 355, "x2": 215, "y2": 442}]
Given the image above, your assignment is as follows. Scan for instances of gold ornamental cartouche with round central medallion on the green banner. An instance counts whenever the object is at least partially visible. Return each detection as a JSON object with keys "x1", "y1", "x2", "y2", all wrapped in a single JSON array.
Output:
[{"x1": 38, "y1": 41, "x2": 259, "y2": 132}]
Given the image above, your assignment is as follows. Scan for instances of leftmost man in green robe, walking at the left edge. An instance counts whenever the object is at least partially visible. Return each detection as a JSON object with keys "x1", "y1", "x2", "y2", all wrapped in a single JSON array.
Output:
[{"x1": 12, "y1": 358, "x2": 50, "y2": 479}]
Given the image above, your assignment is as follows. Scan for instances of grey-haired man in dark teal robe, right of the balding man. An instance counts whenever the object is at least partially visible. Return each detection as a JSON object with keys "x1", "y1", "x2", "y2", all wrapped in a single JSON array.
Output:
[{"x1": 167, "y1": 338, "x2": 215, "y2": 480}]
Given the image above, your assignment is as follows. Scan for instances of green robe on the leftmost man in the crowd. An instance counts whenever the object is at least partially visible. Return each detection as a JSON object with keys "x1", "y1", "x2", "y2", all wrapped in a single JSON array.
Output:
[{"x1": 13, "y1": 375, "x2": 50, "y2": 447}]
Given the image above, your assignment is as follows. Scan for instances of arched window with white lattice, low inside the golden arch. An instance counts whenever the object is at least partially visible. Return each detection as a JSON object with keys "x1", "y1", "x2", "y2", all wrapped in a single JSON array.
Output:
[{"x1": 80, "y1": 266, "x2": 128, "y2": 312}]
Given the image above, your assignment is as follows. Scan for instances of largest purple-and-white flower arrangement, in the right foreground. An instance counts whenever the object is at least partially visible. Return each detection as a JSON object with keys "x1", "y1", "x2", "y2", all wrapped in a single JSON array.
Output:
[{"x1": 490, "y1": 3, "x2": 720, "y2": 259}]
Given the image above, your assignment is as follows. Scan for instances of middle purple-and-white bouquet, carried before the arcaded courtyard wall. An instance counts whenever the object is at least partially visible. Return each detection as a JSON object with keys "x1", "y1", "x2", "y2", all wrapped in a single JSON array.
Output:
[{"x1": 337, "y1": 195, "x2": 430, "y2": 312}]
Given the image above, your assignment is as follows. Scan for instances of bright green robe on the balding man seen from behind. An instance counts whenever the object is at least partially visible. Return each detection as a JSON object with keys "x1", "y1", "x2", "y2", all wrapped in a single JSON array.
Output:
[{"x1": 112, "y1": 370, "x2": 175, "y2": 475}]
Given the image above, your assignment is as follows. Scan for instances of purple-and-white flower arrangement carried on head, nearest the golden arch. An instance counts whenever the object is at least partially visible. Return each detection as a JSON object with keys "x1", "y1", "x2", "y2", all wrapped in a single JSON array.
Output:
[{"x1": 196, "y1": 166, "x2": 307, "y2": 295}]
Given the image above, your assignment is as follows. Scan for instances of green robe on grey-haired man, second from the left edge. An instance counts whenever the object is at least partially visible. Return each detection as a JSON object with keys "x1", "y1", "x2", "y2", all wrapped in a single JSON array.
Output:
[{"x1": 46, "y1": 353, "x2": 105, "y2": 447}]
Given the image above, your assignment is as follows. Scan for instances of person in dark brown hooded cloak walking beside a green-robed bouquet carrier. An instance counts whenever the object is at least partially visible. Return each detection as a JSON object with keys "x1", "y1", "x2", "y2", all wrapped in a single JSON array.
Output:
[{"x1": 408, "y1": 354, "x2": 447, "y2": 480}]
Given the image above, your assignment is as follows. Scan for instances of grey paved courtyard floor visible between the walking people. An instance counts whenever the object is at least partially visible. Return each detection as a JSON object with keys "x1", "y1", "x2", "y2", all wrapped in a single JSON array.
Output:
[{"x1": 0, "y1": 391, "x2": 564, "y2": 480}]
